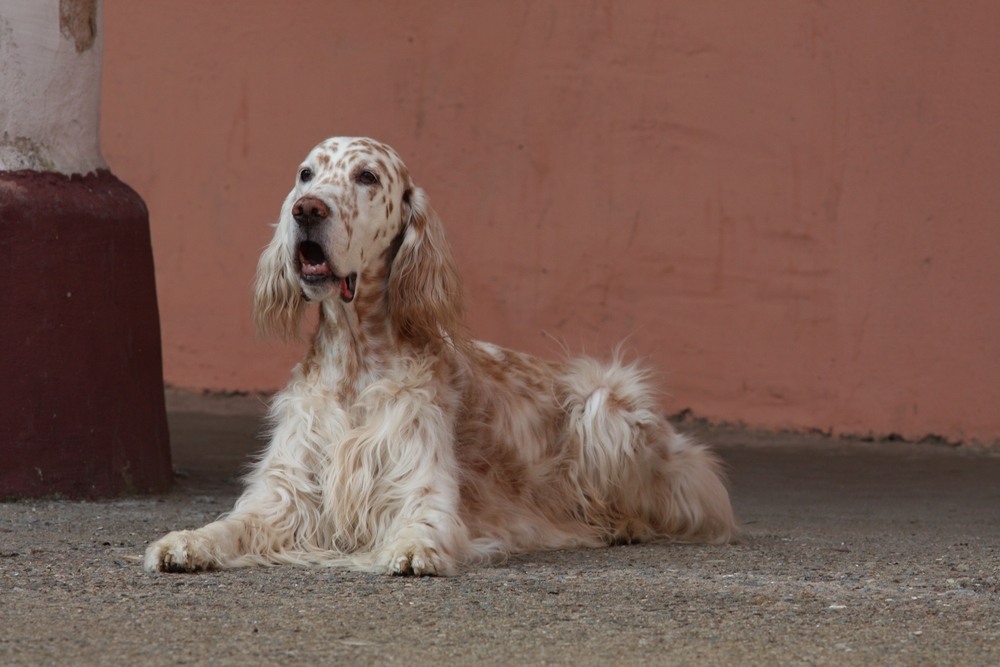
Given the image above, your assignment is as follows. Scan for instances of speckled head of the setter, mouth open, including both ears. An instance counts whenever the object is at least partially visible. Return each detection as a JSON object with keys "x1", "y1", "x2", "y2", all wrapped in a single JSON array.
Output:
[{"x1": 254, "y1": 137, "x2": 461, "y2": 348}]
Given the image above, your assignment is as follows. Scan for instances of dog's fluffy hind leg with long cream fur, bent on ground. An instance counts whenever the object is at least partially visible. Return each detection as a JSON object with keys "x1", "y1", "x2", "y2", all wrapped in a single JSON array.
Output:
[{"x1": 565, "y1": 359, "x2": 736, "y2": 543}]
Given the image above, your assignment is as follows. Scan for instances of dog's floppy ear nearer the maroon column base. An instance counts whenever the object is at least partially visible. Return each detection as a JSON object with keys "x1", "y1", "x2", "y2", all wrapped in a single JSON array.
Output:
[{"x1": 253, "y1": 224, "x2": 306, "y2": 340}]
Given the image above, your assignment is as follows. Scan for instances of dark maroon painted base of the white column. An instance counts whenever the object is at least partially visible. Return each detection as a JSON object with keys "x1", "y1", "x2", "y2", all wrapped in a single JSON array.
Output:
[{"x1": 0, "y1": 171, "x2": 171, "y2": 498}]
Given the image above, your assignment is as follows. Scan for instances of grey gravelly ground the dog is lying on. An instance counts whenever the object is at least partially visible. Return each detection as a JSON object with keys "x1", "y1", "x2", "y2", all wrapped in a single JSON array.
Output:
[{"x1": 0, "y1": 392, "x2": 1000, "y2": 665}]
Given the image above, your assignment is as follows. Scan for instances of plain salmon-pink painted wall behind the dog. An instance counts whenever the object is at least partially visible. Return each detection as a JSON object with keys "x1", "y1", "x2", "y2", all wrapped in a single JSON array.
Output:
[{"x1": 102, "y1": 5, "x2": 1000, "y2": 441}]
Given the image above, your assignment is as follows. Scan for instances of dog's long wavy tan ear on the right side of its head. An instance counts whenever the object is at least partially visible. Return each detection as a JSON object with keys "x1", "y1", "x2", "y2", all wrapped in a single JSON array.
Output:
[{"x1": 389, "y1": 187, "x2": 464, "y2": 347}]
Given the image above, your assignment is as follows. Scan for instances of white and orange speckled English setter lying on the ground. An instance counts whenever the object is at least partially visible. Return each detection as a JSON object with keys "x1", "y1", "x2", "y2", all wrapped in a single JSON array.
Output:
[{"x1": 144, "y1": 138, "x2": 735, "y2": 575}]
